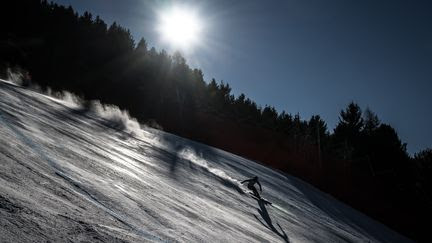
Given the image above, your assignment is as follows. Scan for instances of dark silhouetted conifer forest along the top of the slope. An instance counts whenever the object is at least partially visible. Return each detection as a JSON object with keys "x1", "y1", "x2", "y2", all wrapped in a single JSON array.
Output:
[{"x1": 0, "y1": 0, "x2": 432, "y2": 241}]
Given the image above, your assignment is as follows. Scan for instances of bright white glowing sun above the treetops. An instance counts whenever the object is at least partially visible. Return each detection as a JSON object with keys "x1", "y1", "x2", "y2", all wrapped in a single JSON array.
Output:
[{"x1": 157, "y1": 7, "x2": 202, "y2": 49}]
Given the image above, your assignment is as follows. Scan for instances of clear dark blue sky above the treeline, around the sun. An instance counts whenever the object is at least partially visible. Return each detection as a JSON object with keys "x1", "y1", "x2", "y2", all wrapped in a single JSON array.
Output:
[{"x1": 54, "y1": 0, "x2": 432, "y2": 153}]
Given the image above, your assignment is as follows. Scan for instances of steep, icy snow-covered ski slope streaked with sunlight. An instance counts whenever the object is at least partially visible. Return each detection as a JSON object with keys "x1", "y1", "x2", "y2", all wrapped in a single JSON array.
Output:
[{"x1": 0, "y1": 79, "x2": 409, "y2": 242}]
